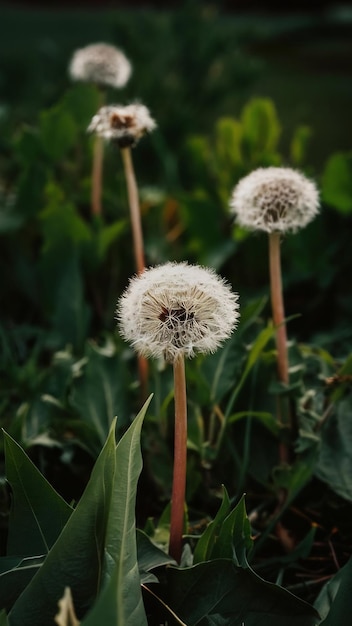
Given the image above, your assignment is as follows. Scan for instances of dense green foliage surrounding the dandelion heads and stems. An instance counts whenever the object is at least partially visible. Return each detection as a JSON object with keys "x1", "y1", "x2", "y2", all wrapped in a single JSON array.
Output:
[{"x1": 0, "y1": 3, "x2": 352, "y2": 626}]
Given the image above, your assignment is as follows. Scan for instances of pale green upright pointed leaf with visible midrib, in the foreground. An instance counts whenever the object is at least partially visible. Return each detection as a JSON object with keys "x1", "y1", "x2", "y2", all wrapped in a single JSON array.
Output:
[{"x1": 82, "y1": 398, "x2": 151, "y2": 626}]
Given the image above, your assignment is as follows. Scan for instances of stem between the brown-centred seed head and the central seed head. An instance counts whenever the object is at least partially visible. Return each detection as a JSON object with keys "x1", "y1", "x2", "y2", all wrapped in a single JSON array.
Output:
[{"x1": 121, "y1": 147, "x2": 145, "y2": 274}]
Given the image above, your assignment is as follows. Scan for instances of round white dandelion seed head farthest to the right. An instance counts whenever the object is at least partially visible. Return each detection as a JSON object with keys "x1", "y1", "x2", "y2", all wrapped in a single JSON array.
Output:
[{"x1": 230, "y1": 167, "x2": 319, "y2": 233}]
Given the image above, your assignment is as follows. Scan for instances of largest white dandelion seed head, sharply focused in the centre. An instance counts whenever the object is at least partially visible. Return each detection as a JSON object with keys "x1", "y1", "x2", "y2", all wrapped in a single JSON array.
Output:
[{"x1": 117, "y1": 263, "x2": 239, "y2": 362}]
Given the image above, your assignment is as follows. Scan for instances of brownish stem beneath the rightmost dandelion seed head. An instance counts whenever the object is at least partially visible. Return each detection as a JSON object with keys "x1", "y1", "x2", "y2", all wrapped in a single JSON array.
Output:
[{"x1": 269, "y1": 232, "x2": 292, "y2": 463}]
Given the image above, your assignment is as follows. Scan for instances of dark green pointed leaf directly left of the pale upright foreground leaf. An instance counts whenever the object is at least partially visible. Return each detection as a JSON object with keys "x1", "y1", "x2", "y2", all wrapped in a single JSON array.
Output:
[{"x1": 9, "y1": 423, "x2": 118, "y2": 626}]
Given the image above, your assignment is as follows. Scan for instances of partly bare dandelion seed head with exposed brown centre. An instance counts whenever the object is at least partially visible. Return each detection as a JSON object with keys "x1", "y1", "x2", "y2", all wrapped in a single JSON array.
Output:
[{"x1": 88, "y1": 104, "x2": 156, "y2": 148}]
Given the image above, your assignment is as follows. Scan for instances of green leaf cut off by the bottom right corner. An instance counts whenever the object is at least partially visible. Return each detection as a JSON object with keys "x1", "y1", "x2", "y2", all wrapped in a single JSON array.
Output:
[{"x1": 314, "y1": 558, "x2": 352, "y2": 626}]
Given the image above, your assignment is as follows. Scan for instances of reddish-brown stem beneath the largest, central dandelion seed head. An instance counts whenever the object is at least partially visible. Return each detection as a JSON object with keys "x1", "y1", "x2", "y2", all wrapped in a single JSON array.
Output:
[{"x1": 169, "y1": 356, "x2": 187, "y2": 563}]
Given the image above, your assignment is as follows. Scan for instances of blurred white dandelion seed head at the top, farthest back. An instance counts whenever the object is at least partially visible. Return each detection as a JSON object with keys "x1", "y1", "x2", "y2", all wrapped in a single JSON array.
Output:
[{"x1": 69, "y1": 43, "x2": 132, "y2": 87}]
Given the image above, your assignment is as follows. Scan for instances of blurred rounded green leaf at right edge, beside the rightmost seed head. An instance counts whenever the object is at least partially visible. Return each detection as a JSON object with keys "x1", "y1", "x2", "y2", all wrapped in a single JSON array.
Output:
[{"x1": 322, "y1": 152, "x2": 352, "y2": 214}]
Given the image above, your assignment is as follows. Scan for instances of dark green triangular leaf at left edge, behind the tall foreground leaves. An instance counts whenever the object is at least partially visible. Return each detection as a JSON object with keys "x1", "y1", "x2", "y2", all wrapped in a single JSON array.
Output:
[{"x1": 4, "y1": 433, "x2": 72, "y2": 556}]
